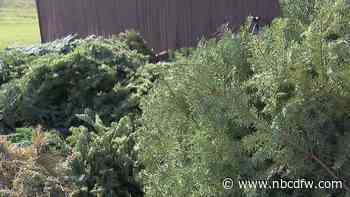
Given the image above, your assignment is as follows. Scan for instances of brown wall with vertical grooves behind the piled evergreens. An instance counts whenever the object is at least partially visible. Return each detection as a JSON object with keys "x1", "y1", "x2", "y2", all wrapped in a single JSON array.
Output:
[{"x1": 36, "y1": 0, "x2": 280, "y2": 51}]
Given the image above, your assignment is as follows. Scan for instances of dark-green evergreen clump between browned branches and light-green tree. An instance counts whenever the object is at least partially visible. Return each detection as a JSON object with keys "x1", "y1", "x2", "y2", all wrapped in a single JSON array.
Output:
[{"x1": 69, "y1": 117, "x2": 143, "y2": 197}]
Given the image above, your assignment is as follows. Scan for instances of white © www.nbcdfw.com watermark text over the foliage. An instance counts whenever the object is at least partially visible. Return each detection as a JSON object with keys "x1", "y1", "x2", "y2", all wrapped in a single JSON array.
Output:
[{"x1": 222, "y1": 178, "x2": 343, "y2": 190}]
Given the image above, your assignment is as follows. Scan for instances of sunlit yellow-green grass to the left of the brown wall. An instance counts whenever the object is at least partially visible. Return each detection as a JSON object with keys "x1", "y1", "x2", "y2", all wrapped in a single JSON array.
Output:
[{"x1": 0, "y1": 0, "x2": 40, "y2": 50}]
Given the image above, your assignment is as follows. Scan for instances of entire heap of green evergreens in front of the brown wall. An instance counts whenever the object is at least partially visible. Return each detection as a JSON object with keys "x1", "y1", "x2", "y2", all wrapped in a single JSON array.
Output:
[{"x1": 0, "y1": 0, "x2": 350, "y2": 197}]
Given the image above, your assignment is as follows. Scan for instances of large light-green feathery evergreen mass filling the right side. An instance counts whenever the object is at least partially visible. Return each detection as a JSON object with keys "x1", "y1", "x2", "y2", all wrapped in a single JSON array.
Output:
[{"x1": 139, "y1": 0, "x2": 350, "y2": 197}]
